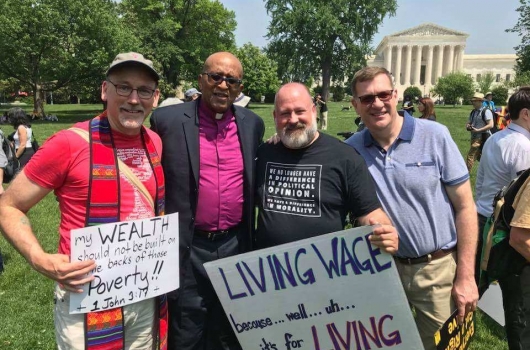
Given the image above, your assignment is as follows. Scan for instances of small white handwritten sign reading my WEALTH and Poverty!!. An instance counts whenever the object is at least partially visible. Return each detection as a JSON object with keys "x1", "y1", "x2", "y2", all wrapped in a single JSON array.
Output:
[{"x1": 70, "y1": 213, "x2": 179, "y2": 314}]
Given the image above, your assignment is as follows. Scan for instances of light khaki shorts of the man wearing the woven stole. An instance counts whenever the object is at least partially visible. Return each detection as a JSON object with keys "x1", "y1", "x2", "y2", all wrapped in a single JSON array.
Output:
[{"x1": 54, "y1": 285, "x2": 158, "y2": 350}]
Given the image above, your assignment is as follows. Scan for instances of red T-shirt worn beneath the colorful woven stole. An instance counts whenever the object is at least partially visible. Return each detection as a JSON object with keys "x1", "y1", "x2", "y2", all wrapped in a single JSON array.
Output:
[{"x1": 24, "y1": 121, "x2": 162, "y2": 255}]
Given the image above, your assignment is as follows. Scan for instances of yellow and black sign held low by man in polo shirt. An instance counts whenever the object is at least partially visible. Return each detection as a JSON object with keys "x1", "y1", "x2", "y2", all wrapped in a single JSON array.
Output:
[{"x1": 434, "y1": 310, "x2": 475, "y2": 350}]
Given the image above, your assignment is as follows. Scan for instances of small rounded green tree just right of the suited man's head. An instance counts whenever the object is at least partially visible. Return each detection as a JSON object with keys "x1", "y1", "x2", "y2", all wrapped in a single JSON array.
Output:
[{"x1": 236, "y1": 43, "x2": 280, "y2": 101}]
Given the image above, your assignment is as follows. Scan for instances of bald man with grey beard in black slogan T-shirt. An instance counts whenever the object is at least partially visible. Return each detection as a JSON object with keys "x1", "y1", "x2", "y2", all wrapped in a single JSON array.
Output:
[{"x1": 256, "y1": 83, "x2": 398, "y2": 254}]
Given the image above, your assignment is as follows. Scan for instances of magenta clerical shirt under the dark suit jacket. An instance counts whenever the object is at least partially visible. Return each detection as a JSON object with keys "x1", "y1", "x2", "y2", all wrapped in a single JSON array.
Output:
[{"x1": 195, "y1": 103, "x2": 243, "y2": 231}]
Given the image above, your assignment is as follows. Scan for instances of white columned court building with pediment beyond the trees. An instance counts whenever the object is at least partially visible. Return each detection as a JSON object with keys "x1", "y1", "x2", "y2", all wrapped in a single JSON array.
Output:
[{"x1": 367, "y1": 23, "x2": 516, "y2": 98}]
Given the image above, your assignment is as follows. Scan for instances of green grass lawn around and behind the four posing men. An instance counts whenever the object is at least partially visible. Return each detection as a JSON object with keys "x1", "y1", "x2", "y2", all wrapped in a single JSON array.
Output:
[{"x1": 0, "y1": 102, "x2": 508, "y2": 350}]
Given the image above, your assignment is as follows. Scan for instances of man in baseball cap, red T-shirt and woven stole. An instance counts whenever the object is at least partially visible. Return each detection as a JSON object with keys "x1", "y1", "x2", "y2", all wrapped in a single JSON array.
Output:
[{"x1": 0, "y1": 52, "x2": 167, "y2": 350}]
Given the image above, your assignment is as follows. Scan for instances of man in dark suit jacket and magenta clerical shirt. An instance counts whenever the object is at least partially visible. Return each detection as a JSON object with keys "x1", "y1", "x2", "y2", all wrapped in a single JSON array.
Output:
[{"x1": 151, "y1": 52, "x2": 265, "y2": 350}]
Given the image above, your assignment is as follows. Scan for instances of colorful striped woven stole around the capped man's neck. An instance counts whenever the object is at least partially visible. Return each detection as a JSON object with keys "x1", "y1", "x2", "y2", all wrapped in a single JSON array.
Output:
[{"x1": 85, "y1": 111, "x2": 168, "y2": 350}]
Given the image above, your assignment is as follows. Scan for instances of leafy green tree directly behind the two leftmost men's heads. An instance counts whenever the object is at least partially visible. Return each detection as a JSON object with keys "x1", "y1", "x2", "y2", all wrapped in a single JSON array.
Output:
[{"x1": 120, "y1": 0, "x2": 237, "y2": 87}]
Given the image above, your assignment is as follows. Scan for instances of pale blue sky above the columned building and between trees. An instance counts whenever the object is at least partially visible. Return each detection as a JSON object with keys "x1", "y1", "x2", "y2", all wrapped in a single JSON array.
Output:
[{"x1": 220, "y1": 0, "x2": 520, "y2": 54}]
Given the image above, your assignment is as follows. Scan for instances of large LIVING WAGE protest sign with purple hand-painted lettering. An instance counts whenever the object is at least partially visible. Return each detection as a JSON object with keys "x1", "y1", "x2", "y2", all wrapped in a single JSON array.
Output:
[{"x1": 204, "y1": 227, "x2": 423, "y2": 350}]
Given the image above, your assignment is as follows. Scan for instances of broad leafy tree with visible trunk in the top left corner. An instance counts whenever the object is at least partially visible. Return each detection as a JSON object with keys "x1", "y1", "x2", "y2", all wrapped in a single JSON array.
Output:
[{"x1": 0, "y1": 0, "x2": 137, "y2": 115}]
